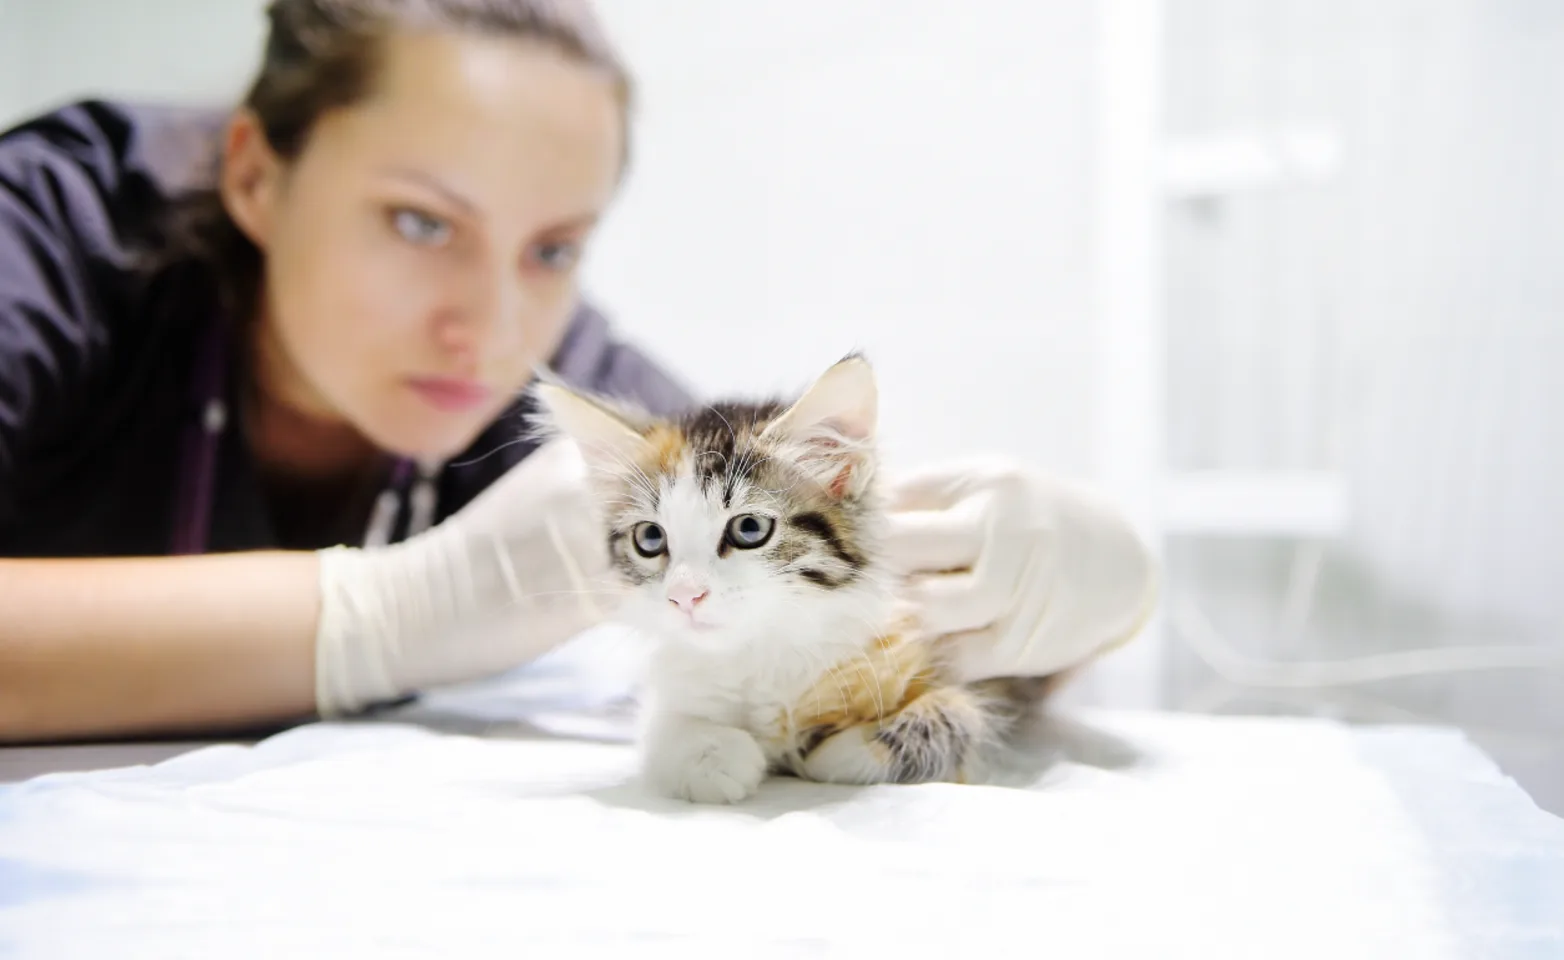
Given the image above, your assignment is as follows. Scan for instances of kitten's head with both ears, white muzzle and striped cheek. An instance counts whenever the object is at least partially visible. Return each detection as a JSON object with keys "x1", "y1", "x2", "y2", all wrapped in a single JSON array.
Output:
[{"x1": 541, "y1": 360, "x2": 874, "y2": 650}]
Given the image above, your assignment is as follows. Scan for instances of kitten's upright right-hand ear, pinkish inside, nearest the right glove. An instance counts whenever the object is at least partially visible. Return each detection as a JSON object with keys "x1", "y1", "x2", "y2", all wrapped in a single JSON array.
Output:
[{"x1": 762, "y1": 355, "x2": 879, "y2": 497}]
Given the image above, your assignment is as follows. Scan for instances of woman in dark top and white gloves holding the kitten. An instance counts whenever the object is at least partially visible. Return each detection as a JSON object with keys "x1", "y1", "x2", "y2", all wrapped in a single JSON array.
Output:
[{"x1": 0, "y1": 0, "x2": 1150, "y2": 741}]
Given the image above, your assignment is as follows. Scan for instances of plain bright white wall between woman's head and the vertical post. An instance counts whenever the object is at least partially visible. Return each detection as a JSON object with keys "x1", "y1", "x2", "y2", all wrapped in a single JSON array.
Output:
[{"x1": 591, "y1": 0, "x2": 1092, "y2": 471}]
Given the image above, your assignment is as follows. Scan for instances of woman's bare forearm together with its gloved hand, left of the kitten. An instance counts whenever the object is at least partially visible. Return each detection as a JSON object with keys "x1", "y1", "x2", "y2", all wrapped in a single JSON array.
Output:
[{"x1": 0, "y1": 444, "x2": 619, "y2": 743}]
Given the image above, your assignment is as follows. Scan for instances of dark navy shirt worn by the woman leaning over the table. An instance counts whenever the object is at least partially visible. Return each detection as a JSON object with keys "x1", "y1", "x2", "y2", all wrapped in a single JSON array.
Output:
[{"x1": 0, "y1": 102, "x2": 690, "y2": 557}]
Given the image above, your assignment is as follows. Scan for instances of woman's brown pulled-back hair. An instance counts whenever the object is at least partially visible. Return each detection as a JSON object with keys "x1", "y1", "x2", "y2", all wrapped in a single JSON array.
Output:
[{"x1": 156, "y1": 0, "x2": 630, "y2": 319}]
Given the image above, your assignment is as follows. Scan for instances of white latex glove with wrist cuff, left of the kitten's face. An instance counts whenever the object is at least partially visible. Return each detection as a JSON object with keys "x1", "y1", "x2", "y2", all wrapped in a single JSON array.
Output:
[{"x1": 316, "y1": 441, "x2": 618, "y2": 716}]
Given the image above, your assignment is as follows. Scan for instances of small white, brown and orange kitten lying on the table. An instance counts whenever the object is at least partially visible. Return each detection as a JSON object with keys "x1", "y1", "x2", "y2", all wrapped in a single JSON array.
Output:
[{"x1": 535, "y1": 356, "x2": 1045, "y2": 804}]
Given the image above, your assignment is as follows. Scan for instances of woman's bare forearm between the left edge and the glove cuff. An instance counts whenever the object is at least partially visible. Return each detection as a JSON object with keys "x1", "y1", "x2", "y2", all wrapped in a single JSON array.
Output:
[{"x1": 0, "y1": 552, "x2": 319, "y2": 743}]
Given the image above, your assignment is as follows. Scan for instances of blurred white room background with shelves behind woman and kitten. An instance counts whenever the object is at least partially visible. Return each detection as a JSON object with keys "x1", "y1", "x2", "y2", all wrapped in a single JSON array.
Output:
[{"x1": 0, "y1": 0, "x2": 1564, "y2": 813}]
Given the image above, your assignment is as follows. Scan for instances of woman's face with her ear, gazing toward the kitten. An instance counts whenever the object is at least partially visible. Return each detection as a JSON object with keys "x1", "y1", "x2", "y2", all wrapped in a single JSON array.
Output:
[{"x1": 224, "y1": 34, "x2": 622, "y2": 458}]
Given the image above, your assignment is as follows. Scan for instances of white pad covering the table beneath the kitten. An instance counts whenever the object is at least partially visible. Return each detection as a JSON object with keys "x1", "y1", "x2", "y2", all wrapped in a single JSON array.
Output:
[{"x1": 0, "y1": 631, "x2": 1564, "y2": 960}]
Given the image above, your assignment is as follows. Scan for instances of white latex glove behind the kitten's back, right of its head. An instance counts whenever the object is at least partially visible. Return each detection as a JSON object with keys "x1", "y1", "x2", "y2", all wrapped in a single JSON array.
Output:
[{"x1": 885, "y1": 463, "x2": 1157, "y2": 680}]
